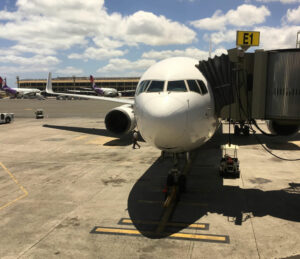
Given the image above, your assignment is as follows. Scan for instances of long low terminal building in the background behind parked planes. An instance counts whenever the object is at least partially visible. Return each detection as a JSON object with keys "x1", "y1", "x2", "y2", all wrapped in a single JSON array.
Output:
[{"x1": 17, "y1": 76, "x2": 140, "y2": 96}]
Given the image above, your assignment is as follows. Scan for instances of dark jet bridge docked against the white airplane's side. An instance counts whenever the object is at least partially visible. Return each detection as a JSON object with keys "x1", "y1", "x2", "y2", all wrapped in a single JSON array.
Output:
[{"x1": 197, "y1": 48, "x2": 300, "y2": 135}]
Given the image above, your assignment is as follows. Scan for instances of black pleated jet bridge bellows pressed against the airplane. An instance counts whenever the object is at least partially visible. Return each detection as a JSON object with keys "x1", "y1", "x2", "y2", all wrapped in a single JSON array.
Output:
[{"x1": 196, "y1": 54, "x2": 234, "y2": 114}]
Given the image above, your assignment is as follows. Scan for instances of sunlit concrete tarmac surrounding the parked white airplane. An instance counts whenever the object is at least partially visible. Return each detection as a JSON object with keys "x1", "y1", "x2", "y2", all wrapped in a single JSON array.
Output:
[{"x1": 0, "y1": 99, "x2": 300, "y2": 259}]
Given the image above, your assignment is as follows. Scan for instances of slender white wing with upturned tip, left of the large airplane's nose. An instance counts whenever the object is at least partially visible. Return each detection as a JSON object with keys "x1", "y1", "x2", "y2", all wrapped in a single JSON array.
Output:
[{"x1": 46, "y1": 73, "x2": 134, "y2": 104}]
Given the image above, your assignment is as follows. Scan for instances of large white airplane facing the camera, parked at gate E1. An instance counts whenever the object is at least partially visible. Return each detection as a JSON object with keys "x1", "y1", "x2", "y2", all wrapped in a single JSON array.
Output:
[{"x1": 46, "y1": 57, "x2": 298, "y2": 186}]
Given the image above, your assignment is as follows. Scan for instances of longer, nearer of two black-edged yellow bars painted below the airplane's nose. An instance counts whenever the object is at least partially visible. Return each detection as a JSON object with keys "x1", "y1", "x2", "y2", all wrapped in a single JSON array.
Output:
[{"x1": 91, "y1": 227, "x2": 229, "y2": 243}]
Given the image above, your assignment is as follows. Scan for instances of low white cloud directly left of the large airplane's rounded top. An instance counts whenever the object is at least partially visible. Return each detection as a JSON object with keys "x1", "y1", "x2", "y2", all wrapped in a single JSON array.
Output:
[{"x1": 97, "y1": 58, "x2": 155, "y2": 75}]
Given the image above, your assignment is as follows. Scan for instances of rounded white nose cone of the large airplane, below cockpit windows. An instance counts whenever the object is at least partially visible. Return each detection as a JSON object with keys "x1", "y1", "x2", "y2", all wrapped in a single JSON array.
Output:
[{"x1": 141, "y1": 95, "x2": 187, "y2": 150}]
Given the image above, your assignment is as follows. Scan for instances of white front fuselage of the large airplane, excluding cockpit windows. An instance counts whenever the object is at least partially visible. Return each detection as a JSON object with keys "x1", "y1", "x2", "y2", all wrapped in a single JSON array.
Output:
[{"x1": 134, "y1": 58, "x2": 218, "y2": 152}]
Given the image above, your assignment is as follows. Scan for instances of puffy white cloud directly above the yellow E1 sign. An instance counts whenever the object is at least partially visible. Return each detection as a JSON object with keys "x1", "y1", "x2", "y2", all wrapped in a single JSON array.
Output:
[{"x1": 191, "y1": 4, "x2": 271, "y2": 30}]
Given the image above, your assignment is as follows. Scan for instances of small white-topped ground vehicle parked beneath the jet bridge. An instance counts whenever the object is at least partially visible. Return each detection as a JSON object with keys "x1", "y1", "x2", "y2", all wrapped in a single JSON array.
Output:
[{"x1": 219, "y1": 144, "x2": 240, "y2": 178}]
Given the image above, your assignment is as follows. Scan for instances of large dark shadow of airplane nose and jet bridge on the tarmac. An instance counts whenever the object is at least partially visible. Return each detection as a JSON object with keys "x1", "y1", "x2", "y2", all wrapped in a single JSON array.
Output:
[{"x1": 128, "y1": 134, "x2": 300, "y2": 238}]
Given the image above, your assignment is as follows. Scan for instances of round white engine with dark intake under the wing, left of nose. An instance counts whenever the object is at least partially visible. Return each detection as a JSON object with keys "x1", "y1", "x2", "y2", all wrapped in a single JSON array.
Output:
[{"x1": 105, "y1": 104, "x2": 136, "y2": 135}]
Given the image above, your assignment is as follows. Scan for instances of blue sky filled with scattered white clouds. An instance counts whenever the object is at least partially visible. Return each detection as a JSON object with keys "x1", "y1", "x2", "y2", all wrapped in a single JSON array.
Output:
[{"x1": 0, "y1": 0, "x2": 300, "y2": 86}]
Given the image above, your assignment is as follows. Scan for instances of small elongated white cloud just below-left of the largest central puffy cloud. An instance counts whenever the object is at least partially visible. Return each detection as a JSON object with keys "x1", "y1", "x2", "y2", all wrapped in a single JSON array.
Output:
[{"x1": 68, "y1": 47, "x2": 126, "y2": 61}]
